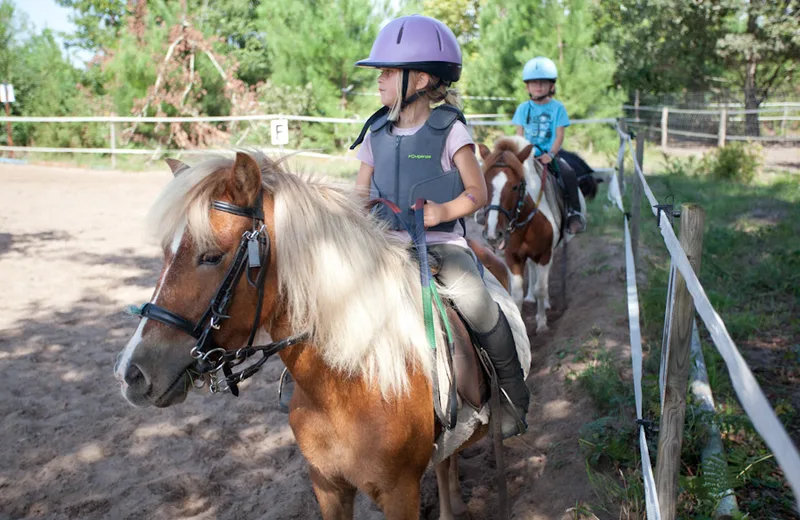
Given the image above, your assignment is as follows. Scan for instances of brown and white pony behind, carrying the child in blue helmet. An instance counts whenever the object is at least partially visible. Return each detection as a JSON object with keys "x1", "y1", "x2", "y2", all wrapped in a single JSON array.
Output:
[{"x1": 476, "y1": 136, "x2": 586, "y2": 332}]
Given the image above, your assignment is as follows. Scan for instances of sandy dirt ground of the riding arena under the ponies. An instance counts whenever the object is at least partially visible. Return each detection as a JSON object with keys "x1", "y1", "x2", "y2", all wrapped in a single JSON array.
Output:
[{"x1": 0, "y1": 161, "x2": 627, "y2": 520}]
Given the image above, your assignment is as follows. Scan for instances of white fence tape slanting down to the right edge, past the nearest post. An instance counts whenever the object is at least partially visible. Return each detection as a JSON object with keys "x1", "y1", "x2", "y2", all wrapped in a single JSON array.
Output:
[{"x1": 620, "y1": 131, "x2": 800, "y2": 499}]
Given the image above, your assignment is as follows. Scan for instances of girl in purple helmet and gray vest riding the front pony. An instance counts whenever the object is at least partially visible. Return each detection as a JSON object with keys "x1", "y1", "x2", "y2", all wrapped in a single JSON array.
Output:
[{"x1": 351, "y1": 15, "x2": 530, "y2": 437}]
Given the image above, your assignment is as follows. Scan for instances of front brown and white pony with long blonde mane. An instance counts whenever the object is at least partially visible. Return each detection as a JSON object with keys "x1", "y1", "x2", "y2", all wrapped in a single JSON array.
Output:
[{"x1": 109, "y1": 153, "x2": 530, "y2": 520}]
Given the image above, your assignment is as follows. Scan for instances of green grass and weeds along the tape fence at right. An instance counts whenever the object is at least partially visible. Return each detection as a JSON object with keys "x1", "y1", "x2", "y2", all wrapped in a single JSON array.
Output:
[{"x1": 571, "y1": 167, "x2": 800, "y2": 519}]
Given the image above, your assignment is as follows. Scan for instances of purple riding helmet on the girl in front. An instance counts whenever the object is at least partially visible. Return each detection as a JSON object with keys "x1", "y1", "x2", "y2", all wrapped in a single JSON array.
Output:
[{"x1": 356, "y1": 14, "x2": 461, "y2": 85}]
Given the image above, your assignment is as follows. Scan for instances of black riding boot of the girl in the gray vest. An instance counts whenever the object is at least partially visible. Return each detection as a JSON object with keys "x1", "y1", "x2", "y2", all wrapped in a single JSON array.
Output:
[{"x1": 475, "y1": 307, "x2": 531, "y2": 439}]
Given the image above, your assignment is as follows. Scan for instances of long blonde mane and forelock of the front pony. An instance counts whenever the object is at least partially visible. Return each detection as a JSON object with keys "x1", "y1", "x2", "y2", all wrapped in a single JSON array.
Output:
[{"x1": 149, "y1": 153, "x2": 442, "y2": 397}]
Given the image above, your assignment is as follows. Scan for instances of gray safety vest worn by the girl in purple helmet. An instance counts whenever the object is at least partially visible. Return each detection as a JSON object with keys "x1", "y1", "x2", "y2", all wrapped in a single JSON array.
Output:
[{"x1": 370, "y1": 105, "x2": 464, "y2": 231}]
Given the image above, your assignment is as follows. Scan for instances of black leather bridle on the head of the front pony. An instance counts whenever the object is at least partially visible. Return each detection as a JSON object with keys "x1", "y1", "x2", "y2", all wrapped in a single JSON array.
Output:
[{"x1": 130, "y1": 191, "x2": 309, "y2": 396}]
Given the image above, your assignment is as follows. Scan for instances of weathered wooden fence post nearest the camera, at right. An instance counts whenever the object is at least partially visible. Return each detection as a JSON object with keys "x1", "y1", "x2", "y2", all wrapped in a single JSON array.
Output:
[{"x1": 656, "y1": 204, "x2": 705, "y2": 520}]
